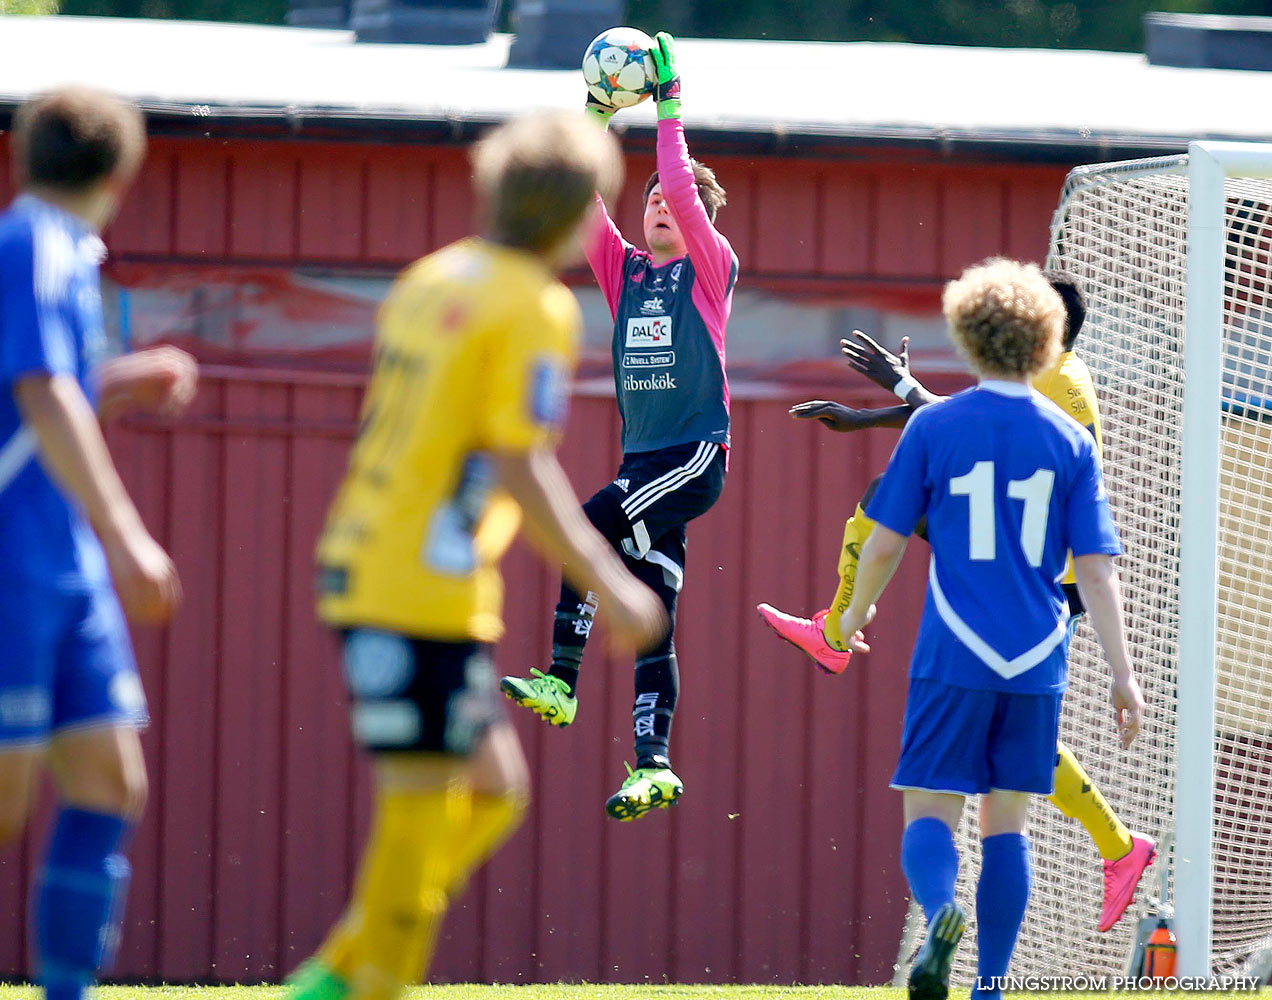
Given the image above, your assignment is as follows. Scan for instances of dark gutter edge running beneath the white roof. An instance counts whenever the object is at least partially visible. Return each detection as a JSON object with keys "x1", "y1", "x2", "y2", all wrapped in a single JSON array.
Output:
[{"x1": 0, "y1": 94, "x2": 1200, "y2": 164}]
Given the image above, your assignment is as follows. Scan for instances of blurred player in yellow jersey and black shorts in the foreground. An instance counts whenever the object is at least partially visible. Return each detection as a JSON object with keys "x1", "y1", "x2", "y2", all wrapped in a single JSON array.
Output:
[{"x1": 287, "y1": 115, "x2": 667, "y2": 1000}]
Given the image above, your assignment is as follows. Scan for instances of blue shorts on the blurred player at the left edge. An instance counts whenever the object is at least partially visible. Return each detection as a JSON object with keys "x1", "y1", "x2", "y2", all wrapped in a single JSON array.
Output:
[{"x1": 0, "y1": 587, "x2": 149, "y2": 751}]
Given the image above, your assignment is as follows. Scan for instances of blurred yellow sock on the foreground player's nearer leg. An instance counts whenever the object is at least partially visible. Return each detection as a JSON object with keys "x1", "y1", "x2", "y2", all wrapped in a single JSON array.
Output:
[{"x1": 319, "y1": 782, "x2": 473, "y2": 1000}]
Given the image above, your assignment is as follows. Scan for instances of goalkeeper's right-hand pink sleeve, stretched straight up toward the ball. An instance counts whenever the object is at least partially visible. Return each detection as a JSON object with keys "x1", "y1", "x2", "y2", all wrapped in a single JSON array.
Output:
[{"x1": 656, "y1": 118, "x2": 735, "y2": 343}]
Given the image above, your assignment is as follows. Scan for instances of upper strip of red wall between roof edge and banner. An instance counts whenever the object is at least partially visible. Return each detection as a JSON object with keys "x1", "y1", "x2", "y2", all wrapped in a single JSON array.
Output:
[{"x1": 89, "y1": 134, "x2": 1065, "y2": 292}]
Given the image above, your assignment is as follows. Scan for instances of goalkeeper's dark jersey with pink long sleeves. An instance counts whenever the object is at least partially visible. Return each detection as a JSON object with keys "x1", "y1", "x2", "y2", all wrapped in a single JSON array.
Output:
[{"x1": 588, "y1": 120, "x2": 738, "y2": 454}]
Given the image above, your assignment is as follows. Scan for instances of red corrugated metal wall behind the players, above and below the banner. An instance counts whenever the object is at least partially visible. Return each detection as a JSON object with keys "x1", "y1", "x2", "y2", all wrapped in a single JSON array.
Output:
[{"x1": 0, "y1": 126, "x2": 1063, "y2": 982}]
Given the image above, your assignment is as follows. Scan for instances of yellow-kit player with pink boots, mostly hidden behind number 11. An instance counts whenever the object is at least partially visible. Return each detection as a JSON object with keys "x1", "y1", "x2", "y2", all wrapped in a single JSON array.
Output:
[{"x1": 758, "y1": 271, "x2": 1156, "y2": 931}]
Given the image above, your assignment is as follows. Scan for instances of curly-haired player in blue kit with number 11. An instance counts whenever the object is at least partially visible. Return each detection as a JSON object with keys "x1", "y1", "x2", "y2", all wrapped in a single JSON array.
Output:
[{"x1": 841, "y1": 260, "x2": 1144, "y2": 997}]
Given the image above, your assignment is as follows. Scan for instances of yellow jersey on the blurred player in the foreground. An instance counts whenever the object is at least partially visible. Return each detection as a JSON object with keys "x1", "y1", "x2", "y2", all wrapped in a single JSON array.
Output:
[{"x1": 318, "y1": 239, "x2": 580, "y2": 642}]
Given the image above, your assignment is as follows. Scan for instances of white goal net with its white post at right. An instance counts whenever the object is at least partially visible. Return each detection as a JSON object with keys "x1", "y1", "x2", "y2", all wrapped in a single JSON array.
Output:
[{"x1": 910, "y1": 144, "x2": 1272, "y2": 983}]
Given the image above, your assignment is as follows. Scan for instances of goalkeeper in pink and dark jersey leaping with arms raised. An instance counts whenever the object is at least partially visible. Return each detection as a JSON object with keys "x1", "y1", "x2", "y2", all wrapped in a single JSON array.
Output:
[{"x1": 501, "y1": 32, "x2": 738, "y2": 819}]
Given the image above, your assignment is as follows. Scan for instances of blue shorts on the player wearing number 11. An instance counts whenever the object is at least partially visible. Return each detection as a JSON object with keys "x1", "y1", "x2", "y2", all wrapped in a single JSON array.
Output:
[{"x1": 892, "y1": 678, "x2": 1063, "y2": 795}]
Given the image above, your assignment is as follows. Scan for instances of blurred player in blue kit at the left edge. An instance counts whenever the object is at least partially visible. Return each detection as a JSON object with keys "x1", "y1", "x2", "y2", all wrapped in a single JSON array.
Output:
[{"x1": 0, "y1": 88, "x2": 197, "y2": 1000}]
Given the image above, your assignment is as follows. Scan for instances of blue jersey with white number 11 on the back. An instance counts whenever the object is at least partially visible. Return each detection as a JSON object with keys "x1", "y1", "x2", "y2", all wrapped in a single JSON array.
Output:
[{"x1": 866, "y1": 382, "x2": 1122, "y2": 693}]
